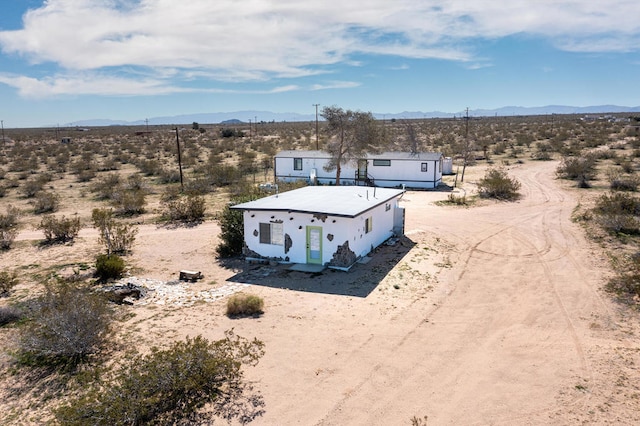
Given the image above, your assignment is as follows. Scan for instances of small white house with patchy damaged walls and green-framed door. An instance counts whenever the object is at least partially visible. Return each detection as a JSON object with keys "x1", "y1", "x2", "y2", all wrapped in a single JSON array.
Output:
[{"x1": 231, "y1": 186, "x2": 404, "y2": 268}]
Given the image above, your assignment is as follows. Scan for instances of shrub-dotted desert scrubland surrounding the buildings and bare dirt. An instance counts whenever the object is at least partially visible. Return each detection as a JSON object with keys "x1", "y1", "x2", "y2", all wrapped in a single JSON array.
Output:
[{"x1": 0, "y1": 112, "x2": 640, "y2": 424}]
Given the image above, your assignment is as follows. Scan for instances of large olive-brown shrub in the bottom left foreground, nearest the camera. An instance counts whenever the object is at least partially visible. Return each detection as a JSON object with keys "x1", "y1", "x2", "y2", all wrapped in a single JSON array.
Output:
[{"x1": 55, "y1": 331, "x2": 264, "y2": 425}]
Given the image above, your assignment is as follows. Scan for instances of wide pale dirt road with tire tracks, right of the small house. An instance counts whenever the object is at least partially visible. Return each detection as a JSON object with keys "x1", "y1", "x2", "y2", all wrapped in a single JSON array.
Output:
[{"x1": 212, "y1": 163, "x2": 638, "y2": 425}]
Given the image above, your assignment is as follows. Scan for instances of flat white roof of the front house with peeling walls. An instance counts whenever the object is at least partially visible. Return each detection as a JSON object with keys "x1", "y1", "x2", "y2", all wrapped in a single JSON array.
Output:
[{"x1": 231, "y1": 186, "x2": 404, "y2": 217}]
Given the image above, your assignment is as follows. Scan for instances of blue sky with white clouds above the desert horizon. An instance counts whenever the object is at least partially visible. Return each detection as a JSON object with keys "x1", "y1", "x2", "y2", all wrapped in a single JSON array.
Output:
[{"x1": 0, "y1": 0, "x2": 640, "y2": 128}]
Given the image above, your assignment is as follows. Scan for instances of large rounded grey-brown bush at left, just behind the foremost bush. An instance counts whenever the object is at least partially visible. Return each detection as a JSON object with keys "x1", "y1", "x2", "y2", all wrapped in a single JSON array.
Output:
[{"x1": 18, "y1": 282, "x2": 113, "y2": 367}]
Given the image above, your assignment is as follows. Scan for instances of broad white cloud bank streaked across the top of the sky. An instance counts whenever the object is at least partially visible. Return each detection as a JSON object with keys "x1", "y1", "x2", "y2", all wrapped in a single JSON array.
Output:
[{"x1": 0, "y1": 0, "x2": 640, "y2": 95}]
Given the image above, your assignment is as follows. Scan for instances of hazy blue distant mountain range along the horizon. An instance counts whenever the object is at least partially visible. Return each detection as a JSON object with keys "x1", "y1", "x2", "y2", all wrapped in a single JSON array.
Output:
[{"x1": 67, "y1": 105, "x2": 640, "y2": 127}]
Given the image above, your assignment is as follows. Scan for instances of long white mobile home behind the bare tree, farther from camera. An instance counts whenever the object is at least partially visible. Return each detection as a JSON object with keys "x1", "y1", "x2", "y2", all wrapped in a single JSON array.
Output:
[{"x1": 273, "y1": 151, "x2": 444, "y2": 189}]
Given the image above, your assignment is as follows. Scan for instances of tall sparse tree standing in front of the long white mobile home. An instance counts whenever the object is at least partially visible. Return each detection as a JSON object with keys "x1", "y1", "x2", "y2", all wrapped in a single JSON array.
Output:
[{"x1": 321, "y1": 106, "x2": 384, "y2": 185}]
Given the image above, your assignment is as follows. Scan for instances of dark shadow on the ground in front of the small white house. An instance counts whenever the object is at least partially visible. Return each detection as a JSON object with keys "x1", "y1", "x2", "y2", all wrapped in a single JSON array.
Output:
[{"x1": 222, "y1": 236, "x2": 415, "y2": 298}]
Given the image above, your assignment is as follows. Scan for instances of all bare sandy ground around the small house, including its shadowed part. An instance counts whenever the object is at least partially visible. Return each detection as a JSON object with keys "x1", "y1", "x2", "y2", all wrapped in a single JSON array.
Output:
[{"x1": 0, "y1": 162, "x2": 640, "y2": 425}]
